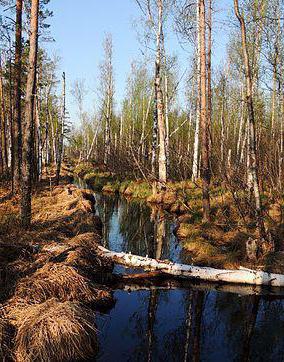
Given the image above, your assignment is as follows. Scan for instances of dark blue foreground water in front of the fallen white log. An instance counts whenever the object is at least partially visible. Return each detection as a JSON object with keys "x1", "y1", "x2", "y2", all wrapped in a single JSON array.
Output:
[{"x1": 95, "y1": 290, "x2": 284, "y2": 361}]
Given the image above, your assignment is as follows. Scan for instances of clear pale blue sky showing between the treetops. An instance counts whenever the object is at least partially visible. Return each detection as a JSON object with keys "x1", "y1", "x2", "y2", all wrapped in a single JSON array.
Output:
[{"x1": 45, "y1": 0, "x2": 233, "y2": 124}]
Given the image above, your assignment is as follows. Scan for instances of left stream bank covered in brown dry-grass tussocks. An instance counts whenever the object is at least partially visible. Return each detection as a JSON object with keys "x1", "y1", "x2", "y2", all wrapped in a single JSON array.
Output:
[{"x1": 0, "y1": 170, "x2": 114, "y2": 362}]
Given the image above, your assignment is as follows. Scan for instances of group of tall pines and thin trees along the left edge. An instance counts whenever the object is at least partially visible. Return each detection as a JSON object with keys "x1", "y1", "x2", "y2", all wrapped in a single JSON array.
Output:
[{"x1": 0, "y1": 0, "x2": 69, "y2": 226}]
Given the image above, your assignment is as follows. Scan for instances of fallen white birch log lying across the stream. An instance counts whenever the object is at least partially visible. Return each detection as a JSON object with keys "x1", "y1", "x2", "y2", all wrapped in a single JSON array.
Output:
[{"x1": 98, "y1": 245, "x2": 284, "y2": 287}]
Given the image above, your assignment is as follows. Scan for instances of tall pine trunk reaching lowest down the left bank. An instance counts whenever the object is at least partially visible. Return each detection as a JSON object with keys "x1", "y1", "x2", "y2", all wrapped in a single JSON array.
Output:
[{"x1": 21, "y1": 0, "x2": 39, "y2": 227}]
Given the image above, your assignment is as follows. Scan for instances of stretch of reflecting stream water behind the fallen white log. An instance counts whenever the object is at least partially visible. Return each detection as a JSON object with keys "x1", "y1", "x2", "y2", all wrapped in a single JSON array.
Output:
[{"x1": 93, "y1": 195, "x2": 184, "y2": 261}]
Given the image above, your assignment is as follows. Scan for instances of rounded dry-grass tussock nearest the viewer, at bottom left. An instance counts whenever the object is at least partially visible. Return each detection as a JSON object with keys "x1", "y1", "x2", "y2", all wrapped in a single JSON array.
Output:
[{"x1": 15, "y1": 299, "x2": 97, "y2": 362}]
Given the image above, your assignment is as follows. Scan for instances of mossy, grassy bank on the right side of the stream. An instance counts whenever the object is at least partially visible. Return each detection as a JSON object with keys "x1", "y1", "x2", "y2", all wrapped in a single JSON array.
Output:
[{"x1": 74, "y1": 163, "x2": 284, "y2": 274}]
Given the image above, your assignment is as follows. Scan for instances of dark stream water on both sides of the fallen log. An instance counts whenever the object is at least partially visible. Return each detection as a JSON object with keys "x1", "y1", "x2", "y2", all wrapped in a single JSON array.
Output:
[{"x1": 74, "y1": 179, "x2": 284, "y2": 362}]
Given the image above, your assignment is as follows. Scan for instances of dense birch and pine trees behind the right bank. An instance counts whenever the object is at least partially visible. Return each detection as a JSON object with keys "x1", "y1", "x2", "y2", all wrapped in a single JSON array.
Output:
[{"x1": 69, "y1": 0, "x2": 284, "y2": 240}]
